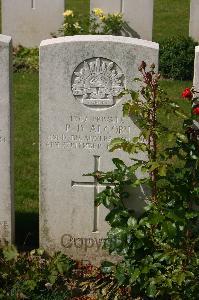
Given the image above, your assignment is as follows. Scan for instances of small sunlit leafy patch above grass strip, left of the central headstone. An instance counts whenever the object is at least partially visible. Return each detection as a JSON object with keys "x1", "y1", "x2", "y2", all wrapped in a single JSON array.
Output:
[{"x1": 13, "y1": 46, "x2": 39, "y2": 72}]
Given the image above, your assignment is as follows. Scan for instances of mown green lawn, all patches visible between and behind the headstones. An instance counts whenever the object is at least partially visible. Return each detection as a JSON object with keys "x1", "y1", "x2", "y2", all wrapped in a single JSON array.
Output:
[{"x1": 14, "y1": 0, "x2": 191, "y2": 247}]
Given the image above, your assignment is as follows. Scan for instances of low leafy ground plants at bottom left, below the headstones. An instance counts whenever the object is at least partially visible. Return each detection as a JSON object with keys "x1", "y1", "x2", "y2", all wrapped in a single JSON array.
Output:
[{"x1": 0, "y1": 246, "x2": 128, "y2": 300}]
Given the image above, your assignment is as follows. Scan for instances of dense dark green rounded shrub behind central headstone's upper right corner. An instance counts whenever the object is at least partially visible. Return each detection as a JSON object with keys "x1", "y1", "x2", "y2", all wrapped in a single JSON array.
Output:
[{"x1": 160, "y1": 37, "x2": 197, "y2": 80}]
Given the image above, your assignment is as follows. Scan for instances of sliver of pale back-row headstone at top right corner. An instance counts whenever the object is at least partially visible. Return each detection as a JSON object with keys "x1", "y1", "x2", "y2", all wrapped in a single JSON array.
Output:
[{"x1": 189, "y1": 0, "x2": 199, "y2": 41}]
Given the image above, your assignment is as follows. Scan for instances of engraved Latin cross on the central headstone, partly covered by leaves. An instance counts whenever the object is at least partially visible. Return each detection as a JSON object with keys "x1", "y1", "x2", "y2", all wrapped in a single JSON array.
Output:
[{"x1": 71, "y1": 155, "x2": 114, "y2": 233}]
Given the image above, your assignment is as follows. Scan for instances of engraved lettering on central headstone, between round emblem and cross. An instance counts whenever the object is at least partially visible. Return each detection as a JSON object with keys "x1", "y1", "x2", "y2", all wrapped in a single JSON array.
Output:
[{"x1": 45, "y1": 115, "x2": 133, "y2": 151}]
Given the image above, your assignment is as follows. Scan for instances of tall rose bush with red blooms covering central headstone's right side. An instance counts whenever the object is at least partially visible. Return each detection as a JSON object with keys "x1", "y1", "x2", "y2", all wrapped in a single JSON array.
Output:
[{"x1": 90, "y1": 62, "x2": 199, "y2": 300}]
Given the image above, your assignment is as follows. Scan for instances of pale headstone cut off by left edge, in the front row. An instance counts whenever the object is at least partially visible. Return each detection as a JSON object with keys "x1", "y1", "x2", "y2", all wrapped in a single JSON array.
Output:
[{"x1": 0, "y1": 35, "x2": 14, "y2": 246}]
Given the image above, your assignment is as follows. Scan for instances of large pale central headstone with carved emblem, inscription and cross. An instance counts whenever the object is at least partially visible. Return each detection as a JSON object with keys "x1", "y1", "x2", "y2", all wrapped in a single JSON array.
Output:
[{"x1": 40, "y1": 36, "x2": 158, "y2": 264}]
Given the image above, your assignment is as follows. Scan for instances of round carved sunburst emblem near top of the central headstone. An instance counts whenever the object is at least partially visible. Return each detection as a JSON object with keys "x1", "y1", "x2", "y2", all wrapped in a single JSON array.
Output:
[{"x1": 72, "y1": 58, "x2": 124, "y2": 108}]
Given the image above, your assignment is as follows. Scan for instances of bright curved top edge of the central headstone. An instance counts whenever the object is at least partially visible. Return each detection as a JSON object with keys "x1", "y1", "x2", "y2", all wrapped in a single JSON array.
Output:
[{"x1": 40, "y1": 35, "x2": 159, "y2": 50}]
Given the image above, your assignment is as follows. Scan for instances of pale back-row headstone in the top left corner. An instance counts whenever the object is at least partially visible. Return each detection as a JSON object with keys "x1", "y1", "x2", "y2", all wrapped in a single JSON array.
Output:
[{"x1": 2, "y1": 0, "x2": 65, "y2": 47}]
